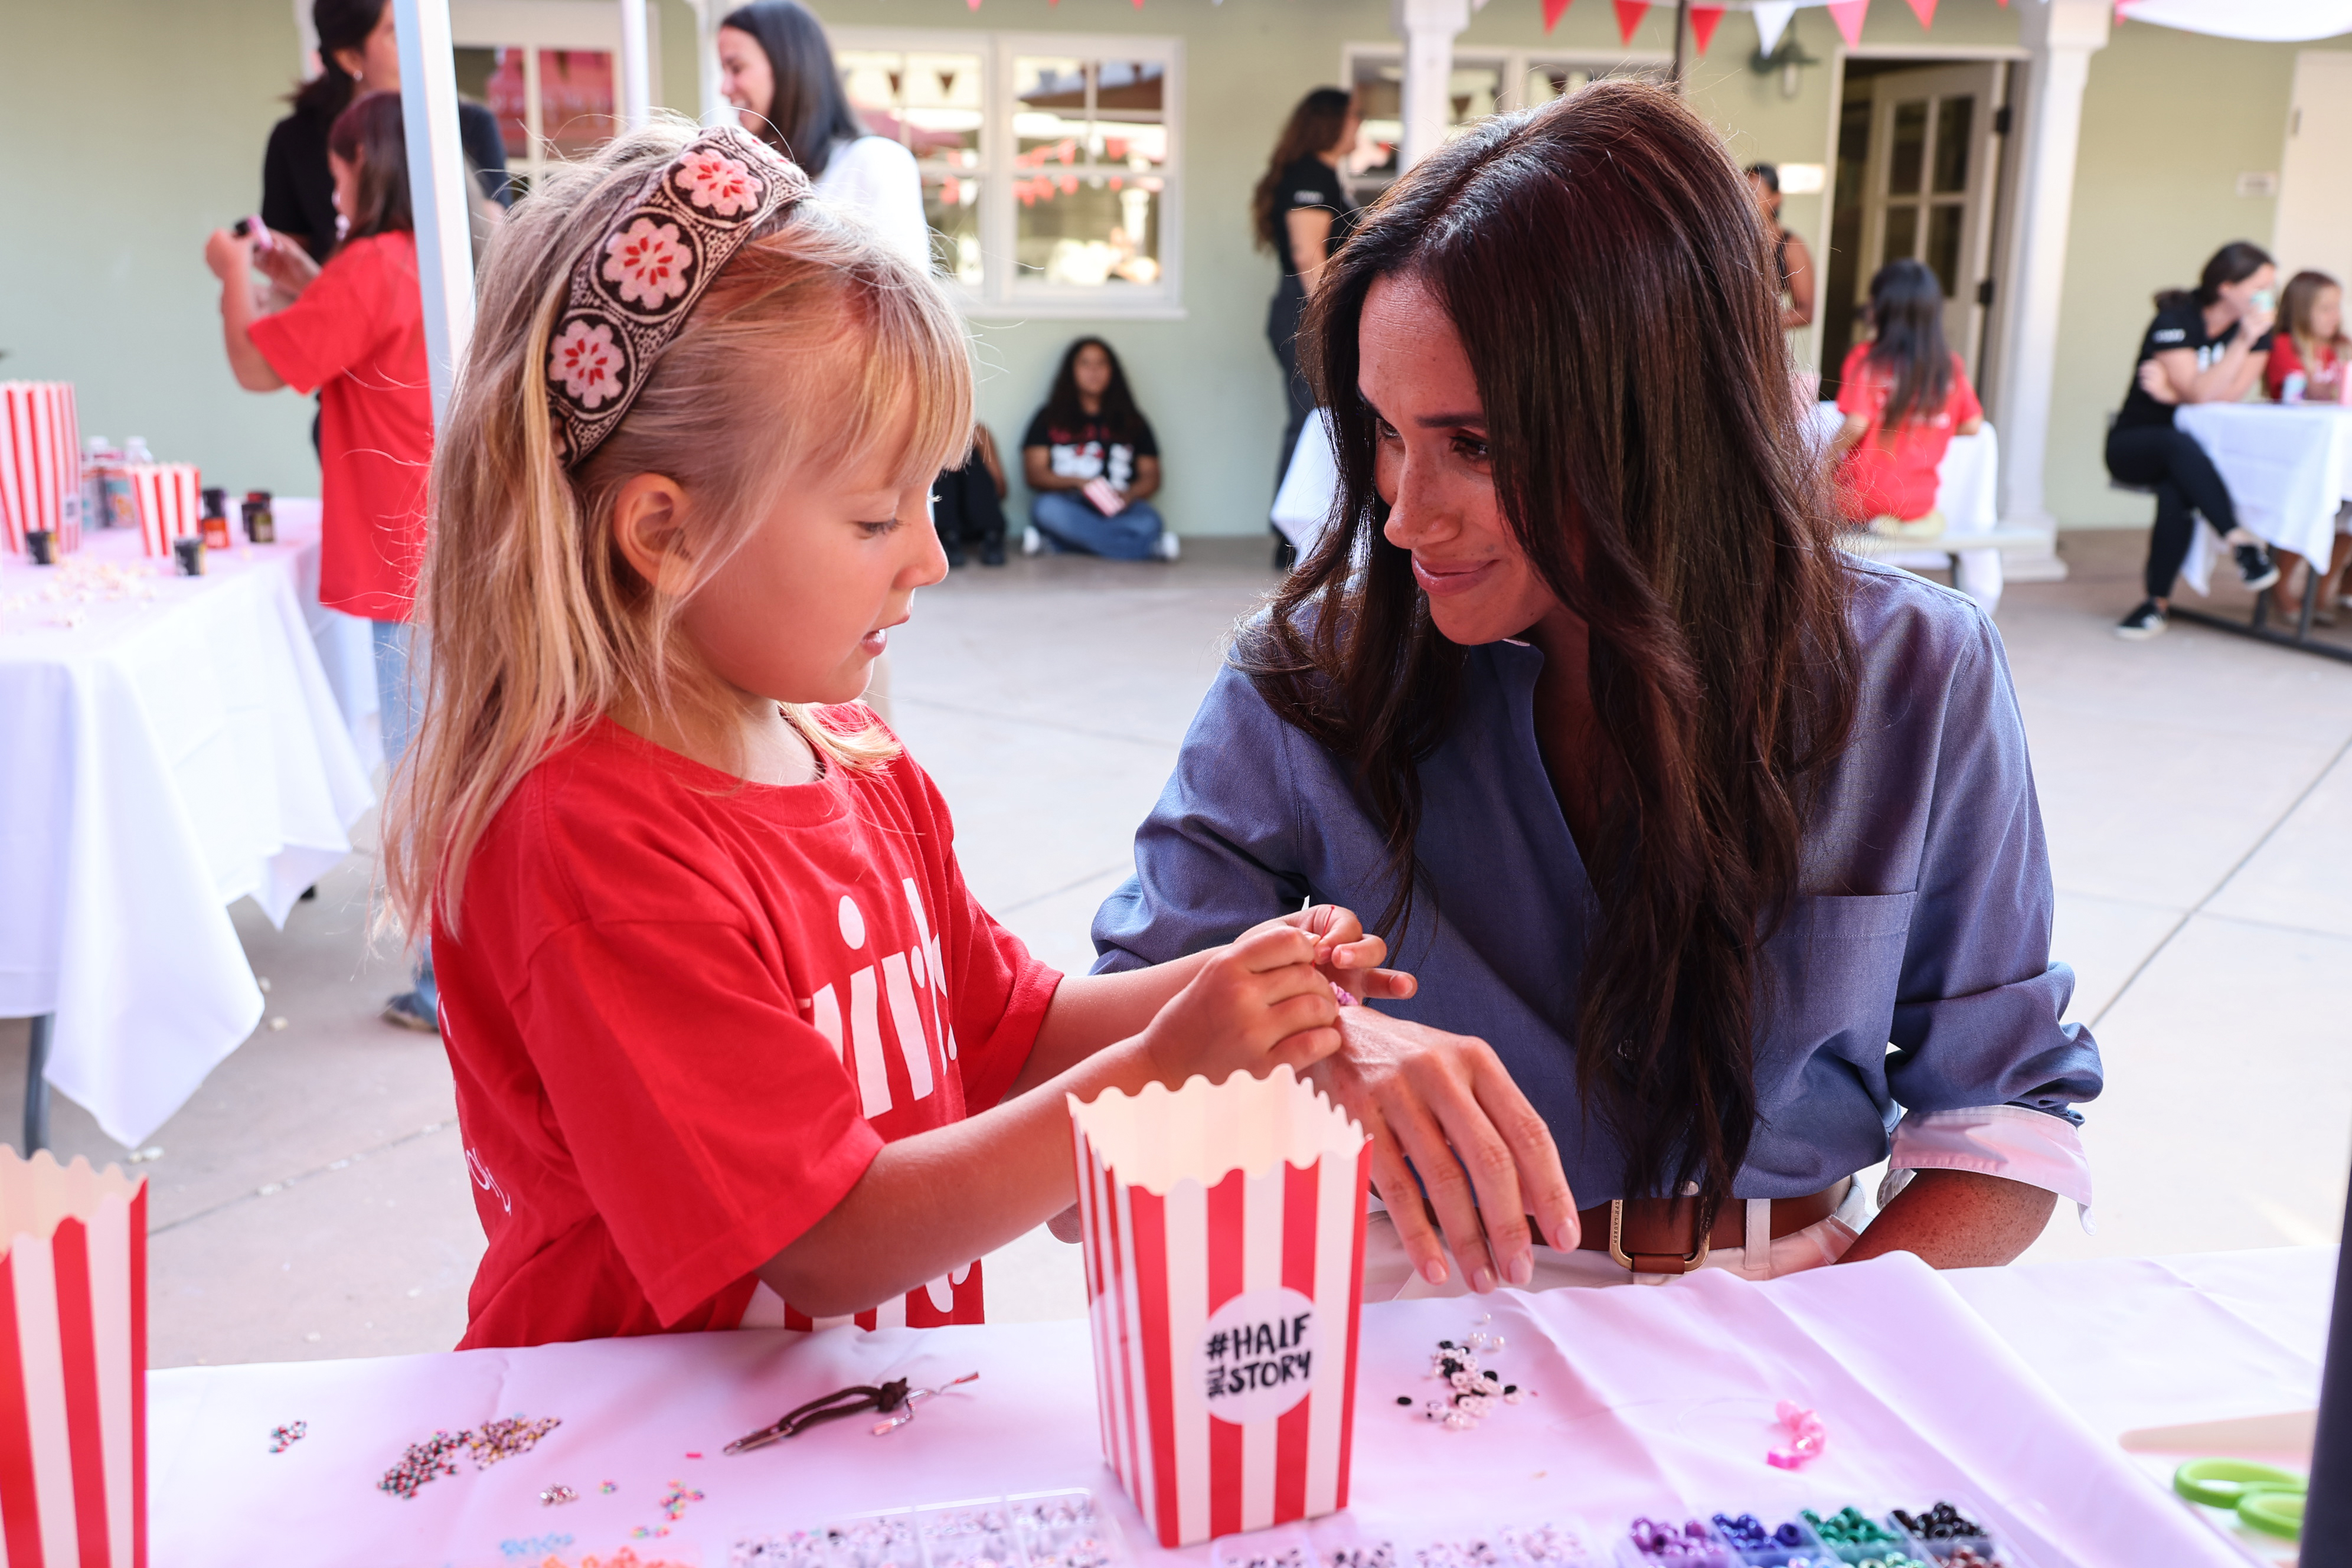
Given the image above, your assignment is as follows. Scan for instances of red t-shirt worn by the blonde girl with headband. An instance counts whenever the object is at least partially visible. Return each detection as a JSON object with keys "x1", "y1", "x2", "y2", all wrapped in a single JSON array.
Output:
[{"x1": 433, "y1": 708, "x2": 1061, "y2": 1350}]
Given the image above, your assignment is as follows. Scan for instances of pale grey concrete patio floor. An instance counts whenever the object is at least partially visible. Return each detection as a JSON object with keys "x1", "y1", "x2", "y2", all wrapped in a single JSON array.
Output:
[{"x1": 0, "y1": 534, "x2": 2352, "y2": 1366}]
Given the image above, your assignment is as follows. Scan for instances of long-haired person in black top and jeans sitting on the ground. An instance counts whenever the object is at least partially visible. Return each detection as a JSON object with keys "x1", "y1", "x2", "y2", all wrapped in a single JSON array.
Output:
[{"x1": 1021, "y1": 338, "x2": 1178, "y2": 562}]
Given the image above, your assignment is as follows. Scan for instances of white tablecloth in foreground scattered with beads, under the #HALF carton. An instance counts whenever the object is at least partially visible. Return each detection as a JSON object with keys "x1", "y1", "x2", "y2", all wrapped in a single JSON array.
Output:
[{"x1": 148, "y1": 1248, "x2": 2333, "y2": 1568}]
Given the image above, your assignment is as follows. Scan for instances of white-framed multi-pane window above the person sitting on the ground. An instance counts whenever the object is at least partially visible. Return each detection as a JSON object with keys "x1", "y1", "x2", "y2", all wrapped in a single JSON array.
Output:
[{"x1": 832, "y1": 28, "x2": 1183, "y2": 318}]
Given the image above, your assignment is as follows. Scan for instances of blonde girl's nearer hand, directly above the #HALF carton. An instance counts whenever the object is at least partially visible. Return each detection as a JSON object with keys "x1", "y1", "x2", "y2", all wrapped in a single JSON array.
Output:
[{"x1": 1141, "y1": 922, "x2": 1341, "y2": 1089}]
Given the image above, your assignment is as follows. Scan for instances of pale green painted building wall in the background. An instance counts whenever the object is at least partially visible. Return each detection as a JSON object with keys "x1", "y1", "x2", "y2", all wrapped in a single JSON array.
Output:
[{"x1": 0, "y1": 0, "x2": 2352, "y2": 534}]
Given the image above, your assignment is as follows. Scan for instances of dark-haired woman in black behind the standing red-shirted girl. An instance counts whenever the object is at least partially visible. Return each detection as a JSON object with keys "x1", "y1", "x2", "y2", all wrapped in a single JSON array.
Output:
[{"x1": 261, "y1": 0, "x2": 515, "y2": 261}]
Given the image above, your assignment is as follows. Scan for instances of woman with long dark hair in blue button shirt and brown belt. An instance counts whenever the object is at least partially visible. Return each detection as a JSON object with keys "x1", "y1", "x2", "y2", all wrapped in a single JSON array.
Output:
[{"x1": 1094, "y1": 82, "x2": 2101, "y2": 1293}]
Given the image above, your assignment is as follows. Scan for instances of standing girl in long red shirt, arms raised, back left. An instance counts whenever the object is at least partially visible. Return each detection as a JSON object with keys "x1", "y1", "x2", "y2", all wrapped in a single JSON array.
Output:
[{"x1": 205, "y1": 92, "x2": 435, "y2": 1030}]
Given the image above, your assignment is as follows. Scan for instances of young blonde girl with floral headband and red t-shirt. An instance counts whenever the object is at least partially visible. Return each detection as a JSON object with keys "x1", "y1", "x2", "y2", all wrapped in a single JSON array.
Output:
[{"x1": 386, "y1": 125, "x2": 1411, "y2": 1347}]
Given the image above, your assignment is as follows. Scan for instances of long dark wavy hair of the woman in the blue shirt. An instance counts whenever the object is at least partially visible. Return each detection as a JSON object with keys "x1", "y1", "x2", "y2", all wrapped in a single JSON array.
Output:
[{"x1": 1237, "y1": 82, "x2": 1856, "y2": 1213}]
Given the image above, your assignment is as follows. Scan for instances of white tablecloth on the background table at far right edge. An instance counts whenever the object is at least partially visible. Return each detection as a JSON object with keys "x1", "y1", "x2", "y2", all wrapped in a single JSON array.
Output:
[{"x1": 2173, "y1": 402, "x2": 2352, "y2": 592}]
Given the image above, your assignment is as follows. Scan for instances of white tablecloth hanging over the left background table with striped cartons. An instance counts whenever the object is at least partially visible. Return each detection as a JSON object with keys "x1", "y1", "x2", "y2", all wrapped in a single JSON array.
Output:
[{"x1": 0, "y1": 522, "x2": 374, "y2": 1145}]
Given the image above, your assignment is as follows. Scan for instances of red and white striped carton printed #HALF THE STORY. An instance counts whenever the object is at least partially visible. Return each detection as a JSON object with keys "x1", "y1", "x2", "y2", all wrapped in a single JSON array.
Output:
[{"x1": 1070, "y1": 1067, "x2": 1371, "y2": 1547}]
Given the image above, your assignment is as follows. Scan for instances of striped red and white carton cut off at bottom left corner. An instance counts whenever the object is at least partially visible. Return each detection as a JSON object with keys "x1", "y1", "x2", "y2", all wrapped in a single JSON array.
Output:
[{"x1": 0, "y1": 1149, "x2": 148, "y2": 1568}]
